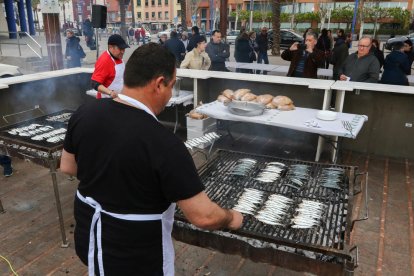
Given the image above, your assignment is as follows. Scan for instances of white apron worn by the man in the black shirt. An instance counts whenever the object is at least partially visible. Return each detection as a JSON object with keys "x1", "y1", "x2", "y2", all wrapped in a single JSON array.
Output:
[{"x1": 76, "y1": 94, "x2": 176, "y2": 276}]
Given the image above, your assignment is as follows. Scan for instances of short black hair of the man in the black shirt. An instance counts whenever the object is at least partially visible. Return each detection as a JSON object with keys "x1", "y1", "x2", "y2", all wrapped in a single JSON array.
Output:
[{"x1": 124, "y1": 43, "x2": 175, "y2": 88}]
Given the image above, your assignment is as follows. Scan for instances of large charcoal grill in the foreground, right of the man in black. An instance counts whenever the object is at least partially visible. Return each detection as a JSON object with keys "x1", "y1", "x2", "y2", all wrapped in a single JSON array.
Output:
[{"x1": 173, "y1": 150, "x2": 367, "y2": 275}]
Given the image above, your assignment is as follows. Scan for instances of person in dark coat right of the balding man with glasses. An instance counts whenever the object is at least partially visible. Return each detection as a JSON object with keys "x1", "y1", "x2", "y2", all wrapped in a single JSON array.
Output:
[{"x1": 381, "y1": 42, "x2": 411, "y2": 85}]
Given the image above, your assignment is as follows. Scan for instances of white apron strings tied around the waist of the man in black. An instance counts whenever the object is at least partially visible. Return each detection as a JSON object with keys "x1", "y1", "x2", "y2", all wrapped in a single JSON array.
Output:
[{"x1": 76, "y1": 191, "x2": 162, "y2": 276}]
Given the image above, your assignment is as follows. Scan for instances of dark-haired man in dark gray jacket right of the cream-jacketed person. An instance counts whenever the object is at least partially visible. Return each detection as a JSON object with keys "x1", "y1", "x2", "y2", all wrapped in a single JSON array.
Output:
[{"x1": 206, "y1": 30, "x2": 230, "y2": 72}]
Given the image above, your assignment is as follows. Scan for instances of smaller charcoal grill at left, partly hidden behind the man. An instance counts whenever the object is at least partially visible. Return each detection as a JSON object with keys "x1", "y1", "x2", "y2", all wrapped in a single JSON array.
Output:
[{"x1": 0, "y1": 110, "x2": 73, "y2": 247}]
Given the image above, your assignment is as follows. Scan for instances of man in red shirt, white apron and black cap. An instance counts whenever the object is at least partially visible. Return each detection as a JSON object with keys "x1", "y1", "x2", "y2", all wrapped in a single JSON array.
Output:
[{"x1": 91, "y1": 34, "x2": 129, "y2": 99}]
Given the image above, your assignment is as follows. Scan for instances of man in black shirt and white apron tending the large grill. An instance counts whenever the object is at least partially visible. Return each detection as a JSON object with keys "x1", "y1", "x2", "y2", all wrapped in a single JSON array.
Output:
[{"x1": 61, "y1": 43, "x2": 243, "y2": 275}]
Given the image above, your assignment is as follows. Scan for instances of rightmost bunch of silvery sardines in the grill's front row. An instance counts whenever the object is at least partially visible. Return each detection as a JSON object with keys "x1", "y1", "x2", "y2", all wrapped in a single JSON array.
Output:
[{"x1": 291, "y1": 200, "x2": 326, "y2": 229}]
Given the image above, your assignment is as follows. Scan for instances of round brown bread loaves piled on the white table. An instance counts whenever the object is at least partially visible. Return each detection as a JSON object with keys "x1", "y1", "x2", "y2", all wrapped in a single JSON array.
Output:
[{"x1": 217, "y1": 88, "x2": 295, "y2": 111}]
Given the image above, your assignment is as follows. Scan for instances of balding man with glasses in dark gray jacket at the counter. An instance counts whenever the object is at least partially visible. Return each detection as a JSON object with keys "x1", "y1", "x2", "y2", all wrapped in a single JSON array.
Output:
[{"x1": 338, "y1": 37, "x2": 380, "y2": 83}]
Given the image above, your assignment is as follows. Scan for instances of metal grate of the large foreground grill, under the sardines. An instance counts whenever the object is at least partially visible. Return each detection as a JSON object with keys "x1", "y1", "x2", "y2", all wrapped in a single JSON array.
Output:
[{"x1": 176, "y1": 150, "x2": 357, "y2": 254}]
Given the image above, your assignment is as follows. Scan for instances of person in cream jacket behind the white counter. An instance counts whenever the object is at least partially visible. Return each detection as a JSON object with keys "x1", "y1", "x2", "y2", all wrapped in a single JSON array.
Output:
[{"x1": 180, "y1": 36, "x2": 211, "y2": 70}]
